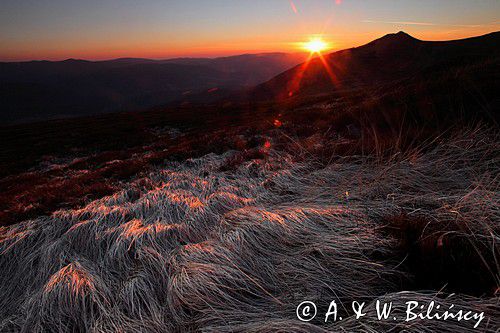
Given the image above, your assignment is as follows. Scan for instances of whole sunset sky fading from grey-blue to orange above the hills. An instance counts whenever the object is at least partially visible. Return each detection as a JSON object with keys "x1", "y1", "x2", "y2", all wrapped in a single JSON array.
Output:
[{"x1": 0, "y1": 0, "x2": 500, "y2": 61}]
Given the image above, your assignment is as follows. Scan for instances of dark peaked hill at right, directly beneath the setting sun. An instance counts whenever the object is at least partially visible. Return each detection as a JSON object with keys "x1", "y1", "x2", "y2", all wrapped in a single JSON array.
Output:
[{"x1": 253, "y1": 32, "x2": 500, "y2": 99}]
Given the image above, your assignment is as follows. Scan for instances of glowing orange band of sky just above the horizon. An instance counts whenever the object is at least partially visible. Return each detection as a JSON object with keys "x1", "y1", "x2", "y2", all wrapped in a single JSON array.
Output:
[{"x1": 1, "y1": 28, "x2": 497, "y2": 61}]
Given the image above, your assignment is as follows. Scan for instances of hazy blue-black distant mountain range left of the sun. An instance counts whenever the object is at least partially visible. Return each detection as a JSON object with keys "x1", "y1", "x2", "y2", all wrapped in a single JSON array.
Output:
[{"x1": 0, "y1": 53, "x2": 304, "y2": 124}]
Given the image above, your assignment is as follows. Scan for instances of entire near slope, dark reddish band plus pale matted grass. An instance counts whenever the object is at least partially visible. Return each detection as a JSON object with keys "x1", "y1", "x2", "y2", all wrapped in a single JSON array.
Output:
[{"x1": 0, "y1": 30, "x2": 500, "y2": 332}]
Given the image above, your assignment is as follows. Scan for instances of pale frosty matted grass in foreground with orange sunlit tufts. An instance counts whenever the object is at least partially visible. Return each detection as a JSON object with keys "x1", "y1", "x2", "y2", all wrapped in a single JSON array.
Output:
[{"x1": 0, "y1": 133, "x2": 500, "y2": 332}]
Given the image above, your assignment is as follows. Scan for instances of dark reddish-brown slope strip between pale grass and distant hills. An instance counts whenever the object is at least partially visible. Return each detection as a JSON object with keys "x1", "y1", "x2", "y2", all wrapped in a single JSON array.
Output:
[{"x1": 0, "y1": 53, "x2": 499, "y2": 225}]
